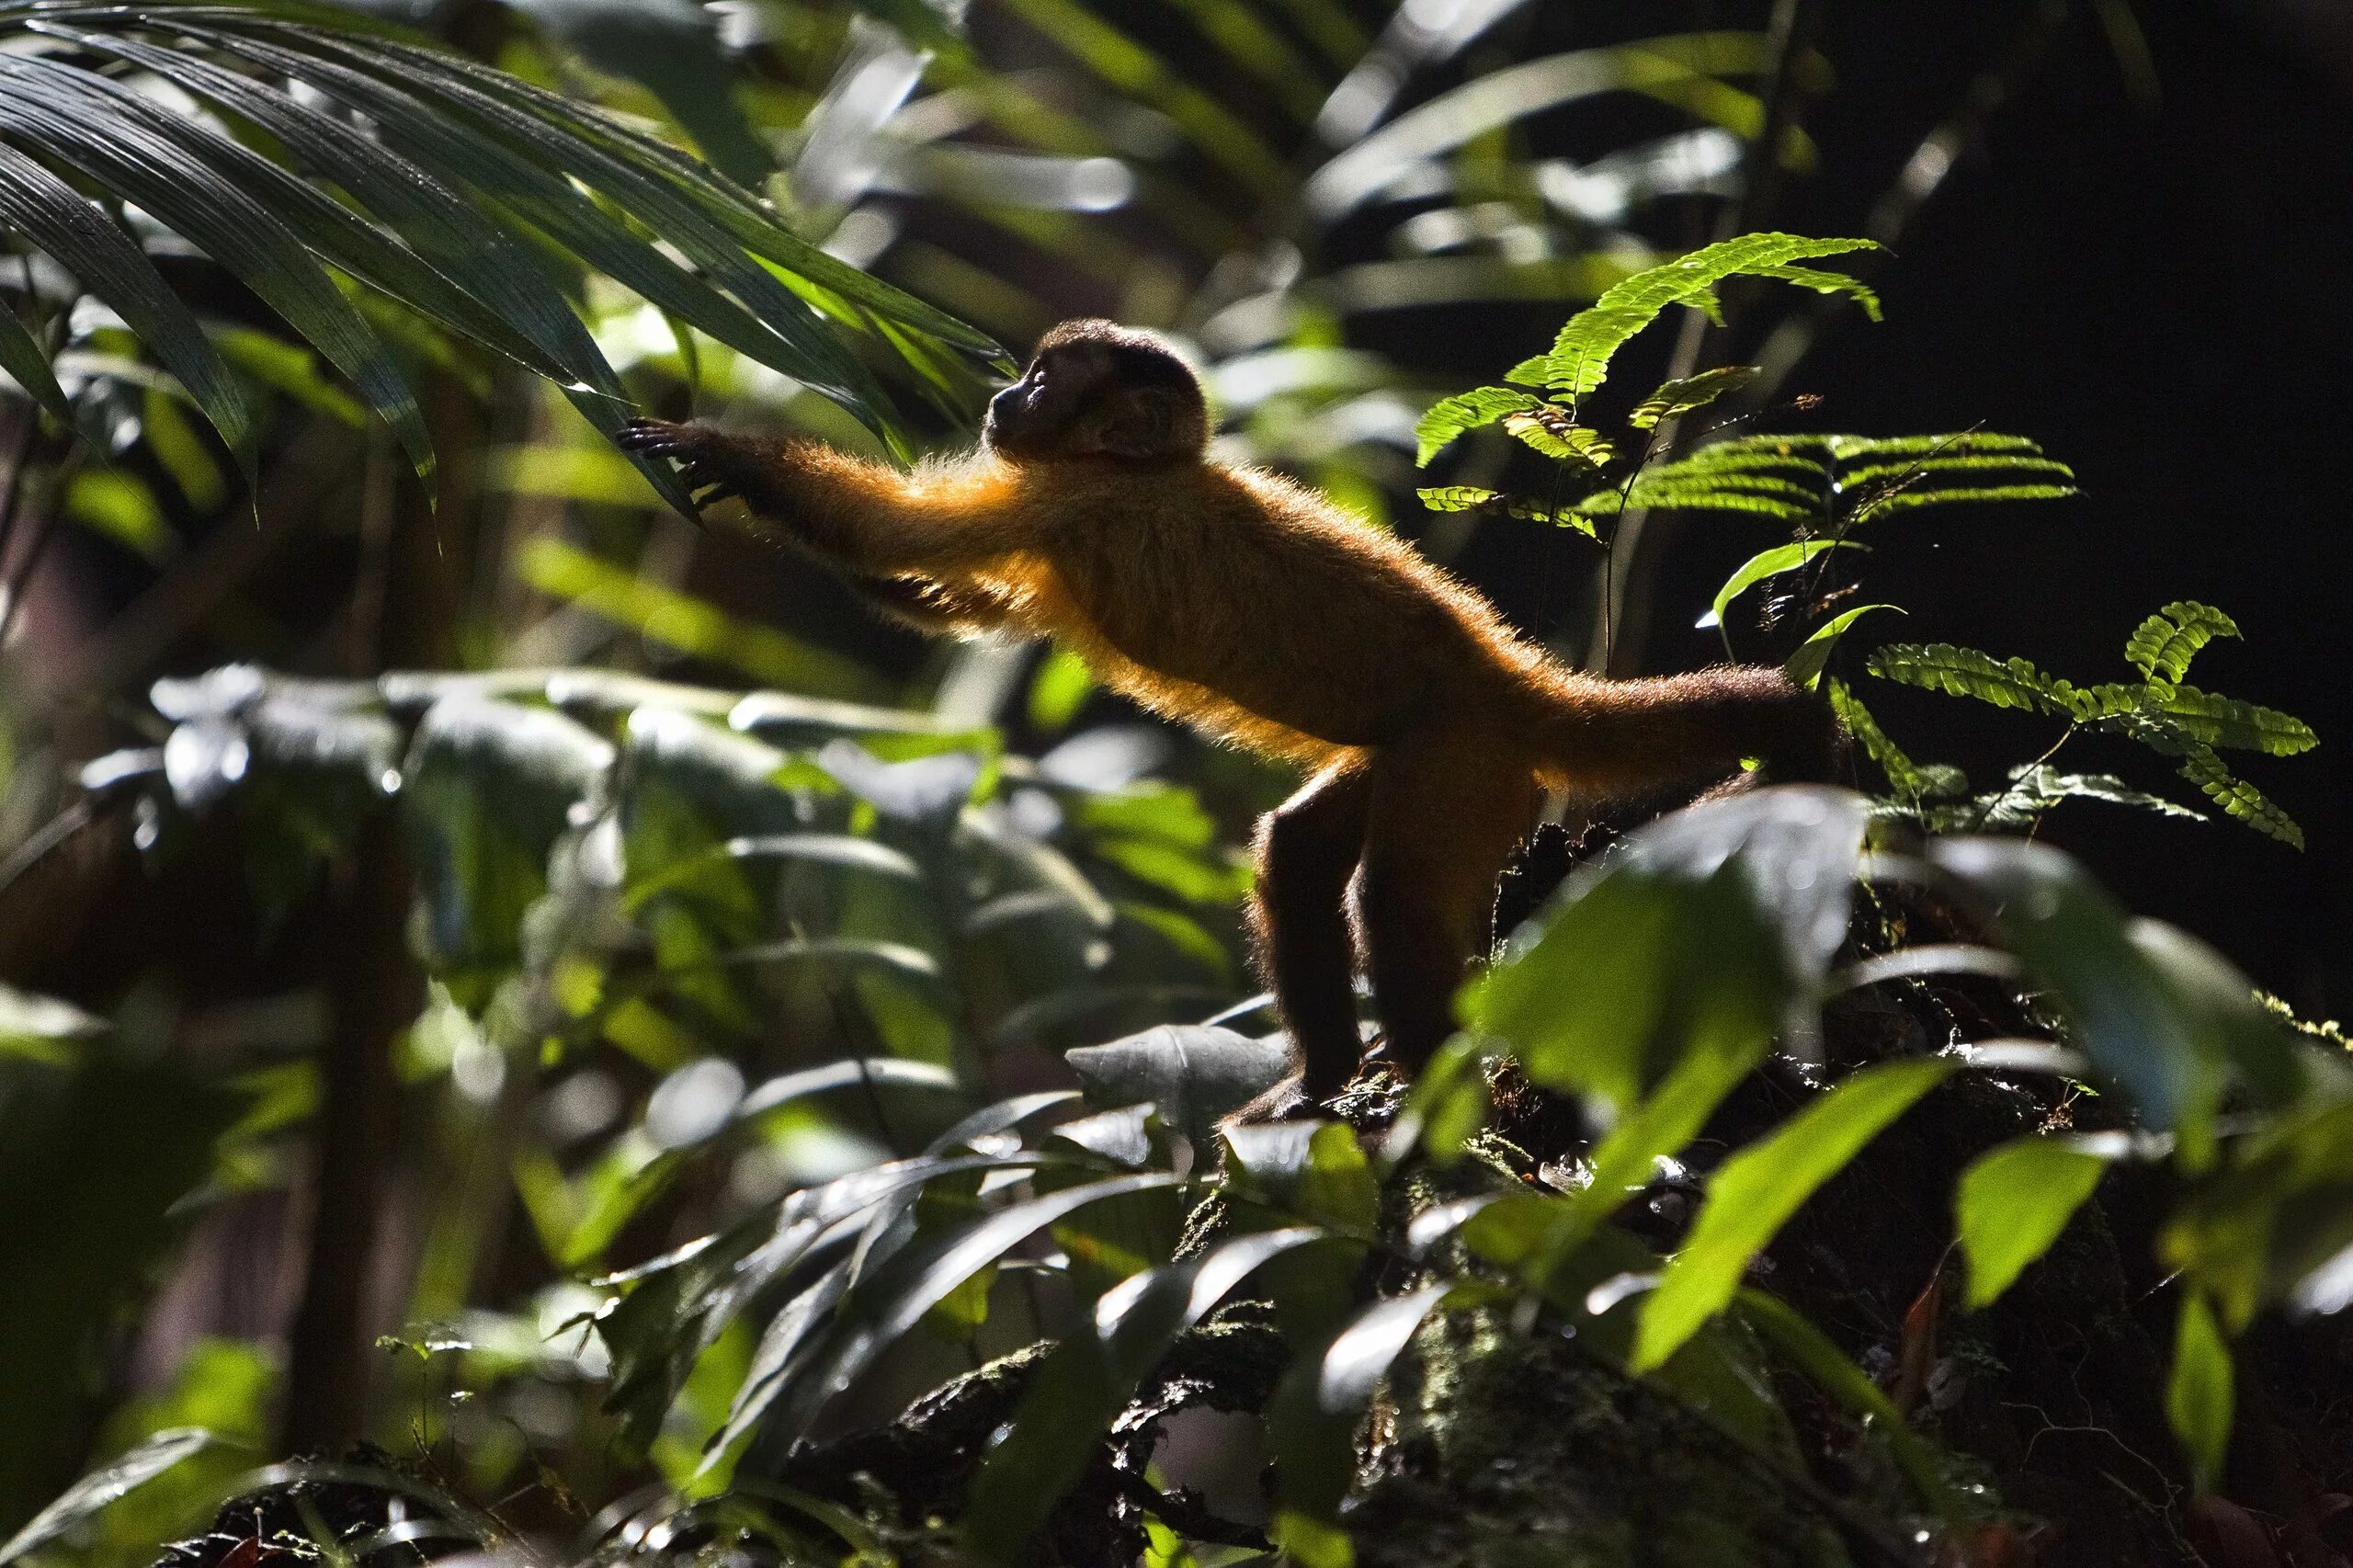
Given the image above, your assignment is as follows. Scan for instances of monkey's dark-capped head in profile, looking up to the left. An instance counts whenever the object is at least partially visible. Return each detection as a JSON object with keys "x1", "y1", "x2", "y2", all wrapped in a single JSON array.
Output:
[{"x1": 982, "y1": 320, "x2": 1210, "y2": 461}]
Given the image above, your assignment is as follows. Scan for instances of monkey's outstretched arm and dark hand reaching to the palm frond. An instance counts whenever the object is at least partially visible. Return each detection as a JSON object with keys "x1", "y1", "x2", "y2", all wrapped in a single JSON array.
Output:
[{"x1": 619, "y1": 419, "x2": 1042, "y2": 579}]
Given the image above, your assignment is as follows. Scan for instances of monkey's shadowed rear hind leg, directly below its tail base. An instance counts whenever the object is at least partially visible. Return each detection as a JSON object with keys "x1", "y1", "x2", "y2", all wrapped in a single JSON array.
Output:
[{"x1": 1358, "y1": 734, "x2": 1543, "y2": 1076}]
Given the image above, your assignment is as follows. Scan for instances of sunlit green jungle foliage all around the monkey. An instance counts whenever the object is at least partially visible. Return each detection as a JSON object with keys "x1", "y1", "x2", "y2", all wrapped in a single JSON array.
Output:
[{"x1": 0, "y1": 0, "x2": 2353, "y2": 1568}]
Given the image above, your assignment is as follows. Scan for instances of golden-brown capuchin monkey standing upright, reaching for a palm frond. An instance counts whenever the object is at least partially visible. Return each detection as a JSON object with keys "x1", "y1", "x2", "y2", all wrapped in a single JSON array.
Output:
[{"x1": 621, "y1": 320, "x2": 1837, "y2": 1119}]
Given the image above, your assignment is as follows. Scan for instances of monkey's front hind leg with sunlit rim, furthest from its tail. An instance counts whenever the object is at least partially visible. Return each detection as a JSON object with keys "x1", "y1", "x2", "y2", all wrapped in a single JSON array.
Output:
[{"x1": 1249, "y1": 758, "x2": 1367, "y2": 1099}]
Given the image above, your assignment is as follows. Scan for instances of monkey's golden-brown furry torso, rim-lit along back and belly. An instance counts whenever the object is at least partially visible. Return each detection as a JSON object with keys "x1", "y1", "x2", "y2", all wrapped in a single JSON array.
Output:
[{"x1": 1024, "y1": 464, "x2": 1543, "y2": 763}]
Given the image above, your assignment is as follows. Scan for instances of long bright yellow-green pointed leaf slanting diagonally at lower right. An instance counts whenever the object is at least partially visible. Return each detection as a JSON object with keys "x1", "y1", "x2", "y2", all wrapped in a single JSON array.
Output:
[{"x1": 1633, "y1": 1057, "x2": 1955, "y2": 1372}]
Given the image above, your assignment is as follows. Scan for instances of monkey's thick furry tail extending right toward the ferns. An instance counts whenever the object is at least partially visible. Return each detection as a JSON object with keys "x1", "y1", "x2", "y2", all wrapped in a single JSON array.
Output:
[{"x1": 1532, "y1": 664, "x2": 1845, "y2": 798}]
